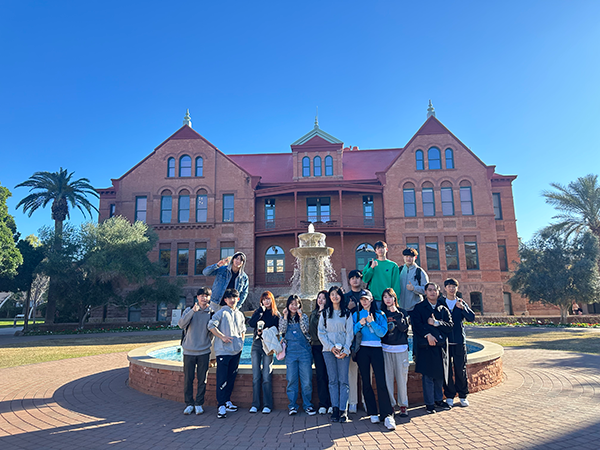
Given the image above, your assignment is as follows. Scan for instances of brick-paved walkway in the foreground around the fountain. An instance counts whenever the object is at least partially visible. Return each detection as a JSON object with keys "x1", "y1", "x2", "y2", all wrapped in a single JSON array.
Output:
[{"x1": 0, "y1": 349, "x2": 600, "y2": 450}]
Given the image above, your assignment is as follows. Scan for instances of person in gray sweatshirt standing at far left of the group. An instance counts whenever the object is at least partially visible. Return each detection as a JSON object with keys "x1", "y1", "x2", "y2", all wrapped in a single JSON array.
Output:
[{"x1": 177, "y1": 287, "x2": 213, "y2": 415}]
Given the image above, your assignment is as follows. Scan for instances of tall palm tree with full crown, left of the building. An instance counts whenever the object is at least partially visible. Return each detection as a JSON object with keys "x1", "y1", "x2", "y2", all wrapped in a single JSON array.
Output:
[{"x1": 16, "y1": 167, "x2": 99, "y2": 323}]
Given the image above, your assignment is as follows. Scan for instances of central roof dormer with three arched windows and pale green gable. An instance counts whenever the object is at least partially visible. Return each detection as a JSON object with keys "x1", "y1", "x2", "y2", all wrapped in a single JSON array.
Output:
[{"x1": 290, "y1": 118, "x2": 344, "y2": 181}]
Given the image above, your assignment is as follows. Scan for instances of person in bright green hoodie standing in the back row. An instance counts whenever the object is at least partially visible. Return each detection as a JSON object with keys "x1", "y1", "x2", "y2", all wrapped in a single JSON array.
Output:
[{"x1": 363, "y1": 241, "x2": 401, "y2": 309}]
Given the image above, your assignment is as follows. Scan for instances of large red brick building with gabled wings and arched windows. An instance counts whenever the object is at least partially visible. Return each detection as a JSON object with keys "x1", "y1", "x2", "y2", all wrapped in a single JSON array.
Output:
[{"x1": 97, "y1": 107, "x2": 526, "y2": 320}]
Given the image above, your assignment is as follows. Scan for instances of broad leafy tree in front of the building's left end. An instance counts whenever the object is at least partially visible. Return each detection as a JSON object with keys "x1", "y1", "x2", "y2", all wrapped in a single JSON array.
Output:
[{"x1": 41, "y1": 217, "x2": 181, "y2": 327}]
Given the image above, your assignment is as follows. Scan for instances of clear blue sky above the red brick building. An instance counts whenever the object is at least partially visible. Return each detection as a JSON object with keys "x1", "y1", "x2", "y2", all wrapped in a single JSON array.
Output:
[{"x1": 0, "y1": 0, "x2": 600, "y2": 243}]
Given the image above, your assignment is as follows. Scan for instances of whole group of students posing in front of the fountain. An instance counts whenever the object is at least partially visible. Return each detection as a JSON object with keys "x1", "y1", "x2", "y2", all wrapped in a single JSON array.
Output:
[{"x1": 179, "y1": 241, "x2": 474, "y2": 430}]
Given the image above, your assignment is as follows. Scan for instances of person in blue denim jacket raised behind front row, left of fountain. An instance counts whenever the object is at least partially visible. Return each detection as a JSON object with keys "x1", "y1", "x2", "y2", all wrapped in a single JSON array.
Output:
[{"x1": 202, "y1": 252, "x2": 248, "y2": 312}]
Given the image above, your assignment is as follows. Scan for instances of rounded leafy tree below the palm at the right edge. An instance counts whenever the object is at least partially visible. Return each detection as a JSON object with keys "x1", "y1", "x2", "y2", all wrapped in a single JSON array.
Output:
[{"x1": 508, "y1": 231, "x2": 600, "y2": 323}]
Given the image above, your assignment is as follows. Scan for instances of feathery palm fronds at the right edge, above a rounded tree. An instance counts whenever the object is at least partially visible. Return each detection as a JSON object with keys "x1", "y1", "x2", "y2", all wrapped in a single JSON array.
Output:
[{"x1": 542, "y1": 174, "x2": 600, "y2": 238}]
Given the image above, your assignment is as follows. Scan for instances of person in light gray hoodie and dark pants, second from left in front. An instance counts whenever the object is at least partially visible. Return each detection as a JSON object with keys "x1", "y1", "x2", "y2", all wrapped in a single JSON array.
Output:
[{"x1": 208, "y1": 289, "x2": 246, "y2": 419}]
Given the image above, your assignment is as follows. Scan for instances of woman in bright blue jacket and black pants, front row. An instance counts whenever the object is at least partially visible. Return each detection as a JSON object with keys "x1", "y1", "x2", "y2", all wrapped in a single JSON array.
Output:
[{"x1": 352, "y1": 289, "x2": 396, "y2": 430}]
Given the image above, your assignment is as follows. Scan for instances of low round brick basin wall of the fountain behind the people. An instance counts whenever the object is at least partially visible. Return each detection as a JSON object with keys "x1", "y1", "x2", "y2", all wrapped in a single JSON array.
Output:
[{"x1": 127, "y1": 339, "x2": 504, "y2": 409}]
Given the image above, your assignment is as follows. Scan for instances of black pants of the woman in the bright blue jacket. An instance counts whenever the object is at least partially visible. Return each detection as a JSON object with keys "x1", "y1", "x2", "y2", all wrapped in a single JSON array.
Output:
[{"x1": 356, "y1": 346, "x2": 394, "y2": 419}]
